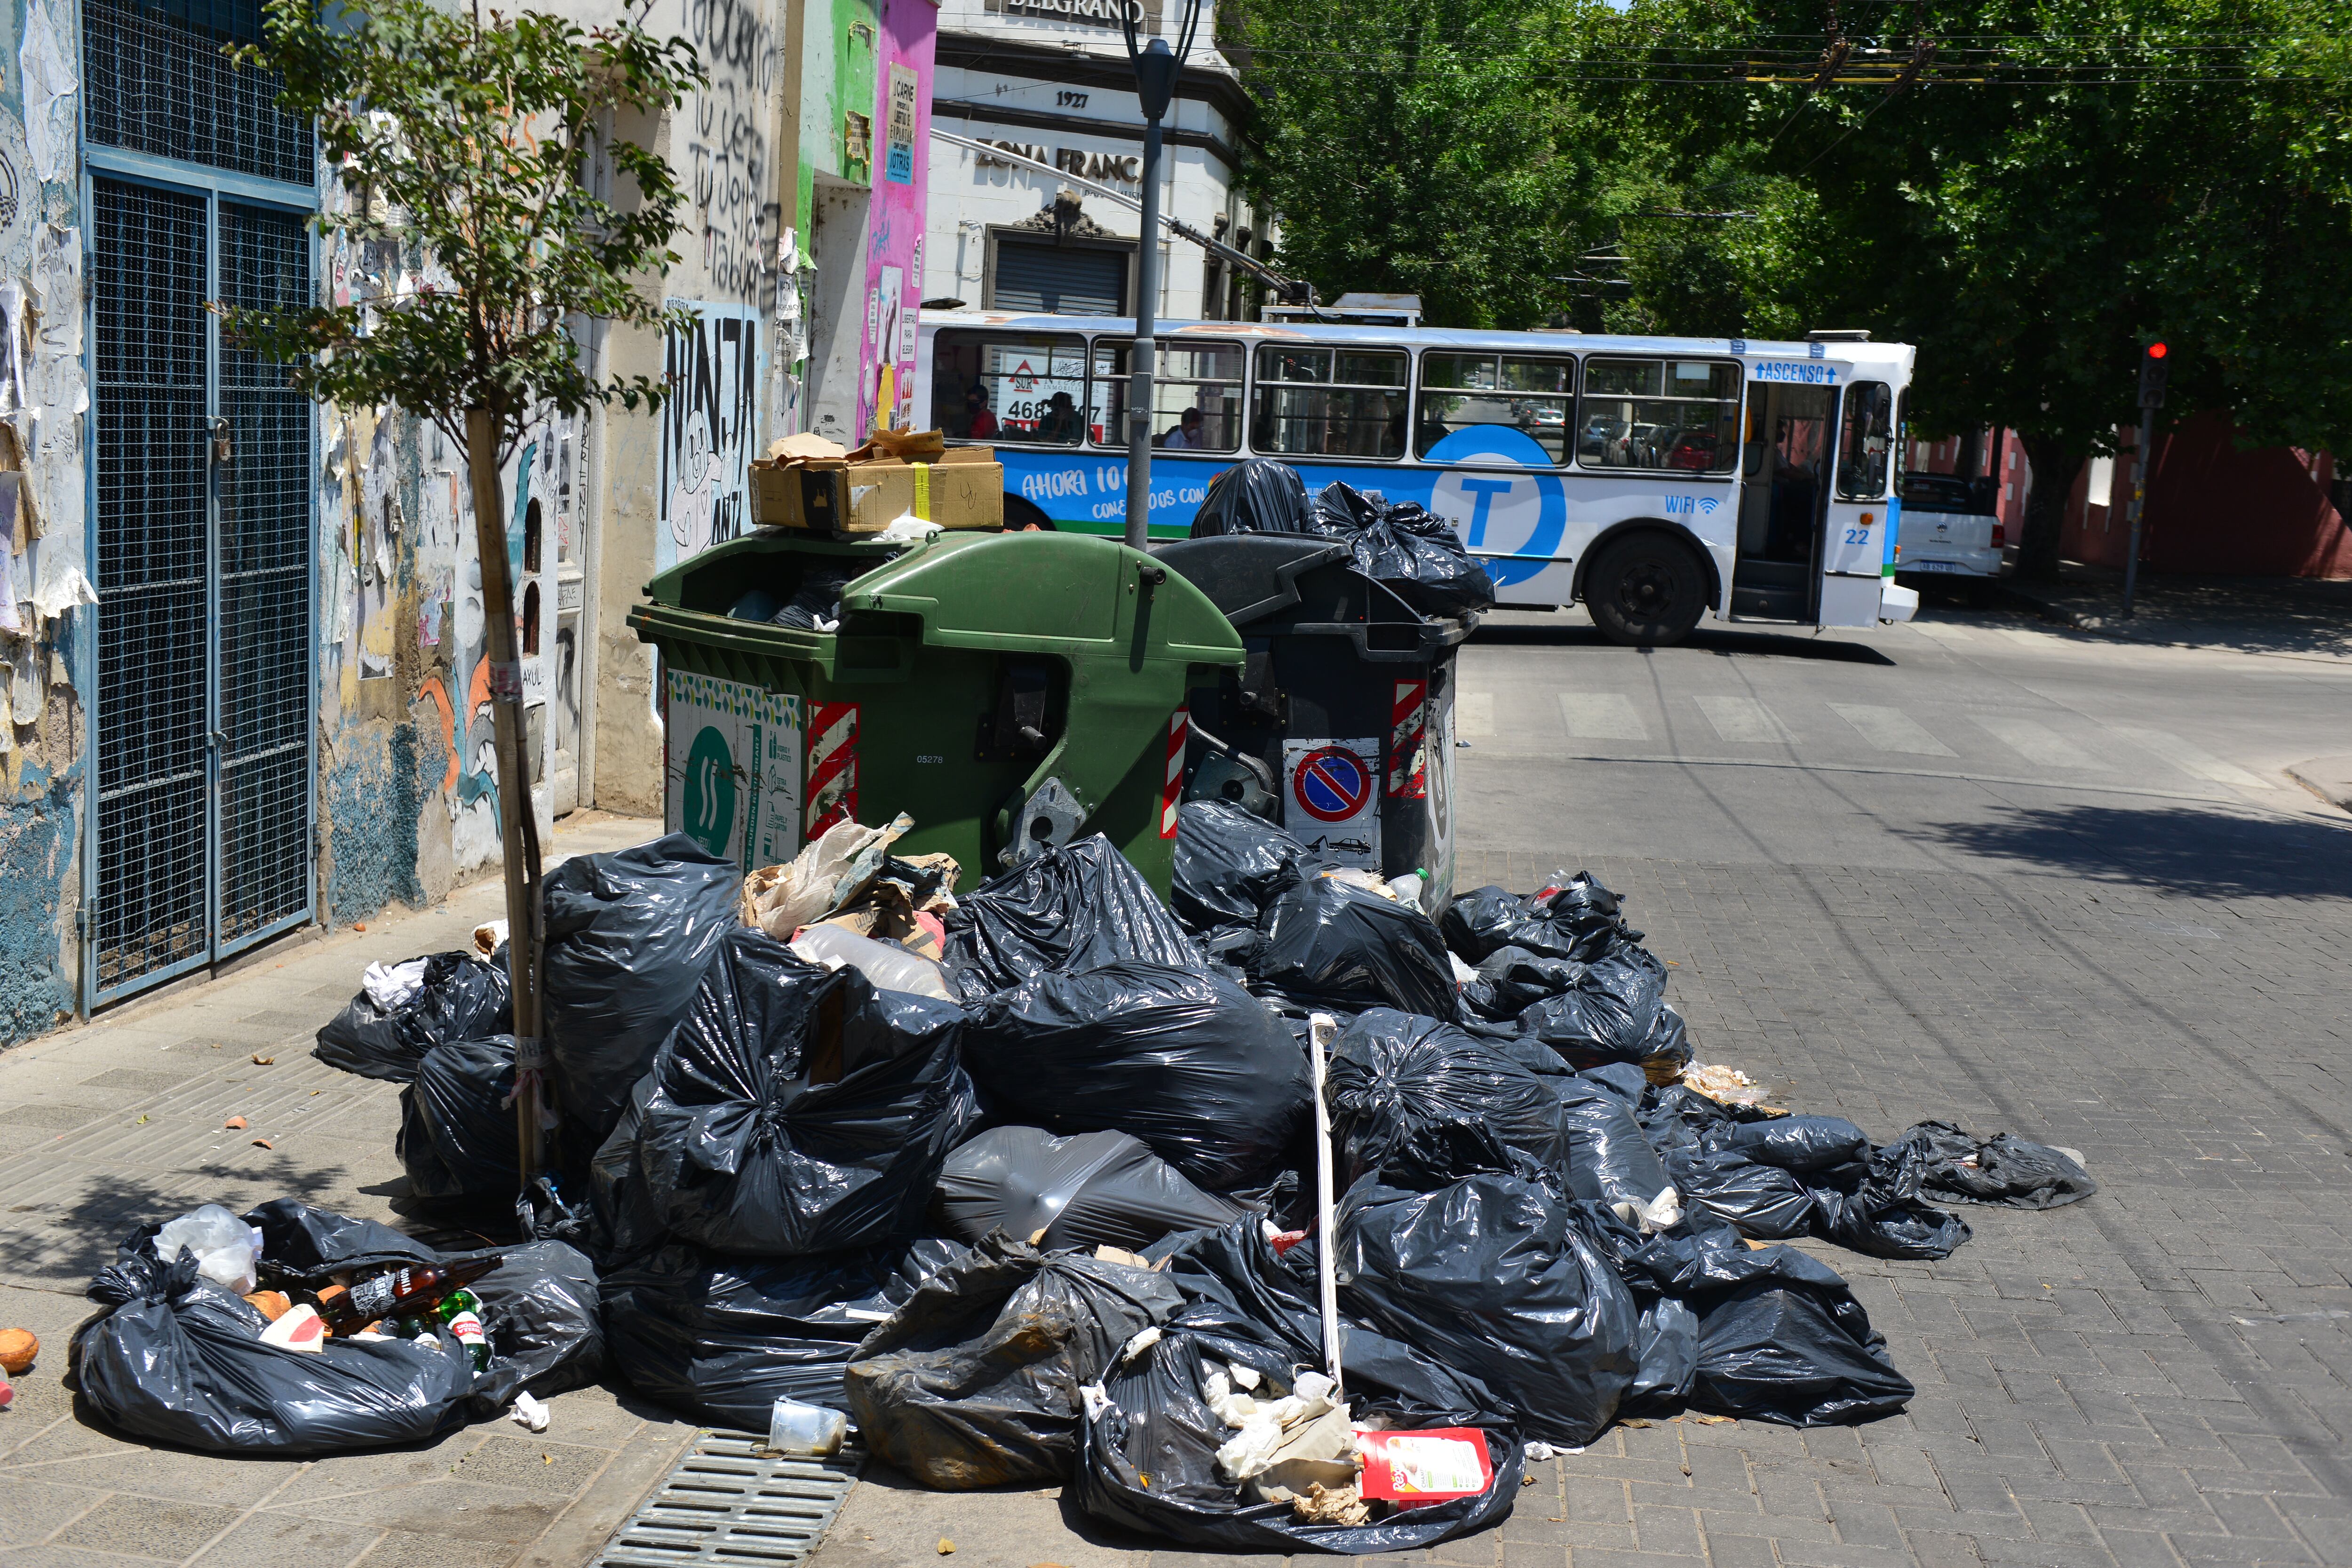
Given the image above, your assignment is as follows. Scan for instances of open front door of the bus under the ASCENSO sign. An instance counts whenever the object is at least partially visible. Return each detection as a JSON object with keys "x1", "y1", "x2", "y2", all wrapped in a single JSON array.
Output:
[{"x1": 1731, "y1": 360, "x2": 1851, "y2": 621}]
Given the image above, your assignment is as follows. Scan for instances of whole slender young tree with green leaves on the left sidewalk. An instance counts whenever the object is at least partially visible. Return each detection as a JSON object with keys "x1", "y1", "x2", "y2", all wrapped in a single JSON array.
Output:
[{"x1": 223, "y1": 0, "x2": 706, "y2": 1182}]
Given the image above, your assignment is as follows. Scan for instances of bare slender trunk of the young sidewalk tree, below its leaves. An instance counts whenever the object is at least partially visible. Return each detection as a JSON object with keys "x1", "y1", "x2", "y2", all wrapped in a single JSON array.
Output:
[{"x1": 466, "y1": 409, "x2": 546, "y2": 1192}]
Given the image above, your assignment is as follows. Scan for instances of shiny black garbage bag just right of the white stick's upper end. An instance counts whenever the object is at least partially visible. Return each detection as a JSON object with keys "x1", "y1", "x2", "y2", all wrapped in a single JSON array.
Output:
[{"x1": 1324, "y1": 1006, "x2": 1571, "y2": 1192}]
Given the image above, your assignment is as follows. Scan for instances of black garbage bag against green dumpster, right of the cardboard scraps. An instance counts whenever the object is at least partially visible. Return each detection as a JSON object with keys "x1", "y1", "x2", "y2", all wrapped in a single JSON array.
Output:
[{"x1": 946, "y1": 835, "x2": 1202, "y2": 1002}]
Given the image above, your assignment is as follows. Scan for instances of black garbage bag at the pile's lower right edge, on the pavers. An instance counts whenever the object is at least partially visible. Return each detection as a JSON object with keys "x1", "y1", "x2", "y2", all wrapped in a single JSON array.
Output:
[{"x1": 1691, "y1": 1246, "x2": 1912, "y2": 1427}]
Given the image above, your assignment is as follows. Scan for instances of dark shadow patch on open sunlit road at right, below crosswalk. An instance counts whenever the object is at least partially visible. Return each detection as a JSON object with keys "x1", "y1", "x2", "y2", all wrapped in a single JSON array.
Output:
[{"x1": 1922, "y1": 806, "x2": 2352, "y2": 898}]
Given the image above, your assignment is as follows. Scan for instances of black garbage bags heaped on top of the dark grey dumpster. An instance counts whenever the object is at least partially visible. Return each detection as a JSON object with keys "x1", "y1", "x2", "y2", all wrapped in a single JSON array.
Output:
[{"x1": 1192, "y1": 458, "x2": 1494, "y2": 616}]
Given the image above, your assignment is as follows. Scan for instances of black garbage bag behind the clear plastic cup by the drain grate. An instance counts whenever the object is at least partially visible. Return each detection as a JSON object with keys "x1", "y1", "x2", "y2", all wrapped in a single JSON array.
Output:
[{"x1": 604, "y1": 1241, "x2": 964, "y2": 1432}]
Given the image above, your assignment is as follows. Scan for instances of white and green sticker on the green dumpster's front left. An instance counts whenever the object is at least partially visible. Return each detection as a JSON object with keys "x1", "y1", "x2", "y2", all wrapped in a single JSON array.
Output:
[{"x1": 663, "y1": 670, "x2": 800, "y2": 872}]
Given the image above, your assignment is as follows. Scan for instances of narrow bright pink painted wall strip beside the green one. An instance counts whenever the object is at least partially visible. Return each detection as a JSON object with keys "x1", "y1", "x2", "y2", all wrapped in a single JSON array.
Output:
[{"x1": 858, "y1": 0, "x2": 938, "y2": 432}]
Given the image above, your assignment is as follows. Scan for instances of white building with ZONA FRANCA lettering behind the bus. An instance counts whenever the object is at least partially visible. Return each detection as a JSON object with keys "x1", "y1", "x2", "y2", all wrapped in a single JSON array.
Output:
[{"x1": 922, "y1": 0, "x2": 1265, "y2": 320}]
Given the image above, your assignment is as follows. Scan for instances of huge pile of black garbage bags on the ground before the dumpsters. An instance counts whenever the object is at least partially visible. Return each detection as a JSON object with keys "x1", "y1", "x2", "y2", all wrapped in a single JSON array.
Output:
[{"x1": 75, "y1": 822, "x2": 2093, "y2": 1554}]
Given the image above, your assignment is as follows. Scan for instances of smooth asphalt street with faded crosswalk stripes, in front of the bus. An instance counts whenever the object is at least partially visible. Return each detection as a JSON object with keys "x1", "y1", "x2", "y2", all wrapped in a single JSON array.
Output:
[{"x1": 1456, "y1": 609, "x2": 2352, "y2": 893}]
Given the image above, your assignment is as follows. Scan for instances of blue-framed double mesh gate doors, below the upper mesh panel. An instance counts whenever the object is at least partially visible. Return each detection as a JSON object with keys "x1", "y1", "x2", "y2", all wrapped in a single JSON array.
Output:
[{"x1": 92, "y1": 179, "x2": 310, "y2": 999}]
